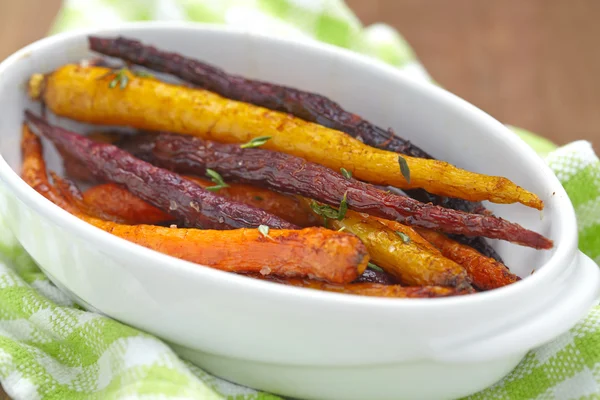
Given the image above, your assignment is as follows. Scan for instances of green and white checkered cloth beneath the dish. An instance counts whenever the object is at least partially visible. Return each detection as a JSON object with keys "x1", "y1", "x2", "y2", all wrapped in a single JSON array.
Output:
[{"x1": 0, "y1": 0, "x2": 600, "y2": 400}]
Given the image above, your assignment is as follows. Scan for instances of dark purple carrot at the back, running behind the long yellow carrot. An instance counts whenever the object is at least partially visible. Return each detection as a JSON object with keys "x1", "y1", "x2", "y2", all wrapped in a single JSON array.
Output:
[{"x1": 88, "y1": 36, "x2": 485, "y2": 216}]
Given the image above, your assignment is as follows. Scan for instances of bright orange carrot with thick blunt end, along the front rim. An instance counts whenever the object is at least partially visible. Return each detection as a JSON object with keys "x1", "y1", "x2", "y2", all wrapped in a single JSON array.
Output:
[{"x1": 22, "y1": 126, "x2": 369, "y2": 283}]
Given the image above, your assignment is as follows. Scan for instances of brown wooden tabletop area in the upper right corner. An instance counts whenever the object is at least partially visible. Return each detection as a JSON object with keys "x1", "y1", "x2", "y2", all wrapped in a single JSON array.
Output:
[{"x1": 347, "y1": 0, "x2": 600, "y2": 149}]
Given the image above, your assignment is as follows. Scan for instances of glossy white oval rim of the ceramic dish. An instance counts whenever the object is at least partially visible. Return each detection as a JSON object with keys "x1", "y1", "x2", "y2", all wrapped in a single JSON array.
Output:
[{"x1": 0, "y1": 21, "x2": 578, "y2": 309}]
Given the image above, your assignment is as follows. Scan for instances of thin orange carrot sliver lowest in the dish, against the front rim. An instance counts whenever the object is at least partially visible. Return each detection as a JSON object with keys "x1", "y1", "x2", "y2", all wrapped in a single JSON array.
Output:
[{"x1": 255, "y1": 278, "x2": 473, "y2": 298}]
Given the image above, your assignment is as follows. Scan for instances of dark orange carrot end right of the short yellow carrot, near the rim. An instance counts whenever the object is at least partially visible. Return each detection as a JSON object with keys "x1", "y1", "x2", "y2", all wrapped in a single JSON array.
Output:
[{"x1": 417, "y1": 229, "x2": 520, "y2": 290}]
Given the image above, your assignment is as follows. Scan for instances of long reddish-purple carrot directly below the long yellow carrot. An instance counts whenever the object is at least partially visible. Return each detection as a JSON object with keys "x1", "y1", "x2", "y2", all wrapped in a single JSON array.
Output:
[{"x1": 121, "y1": 133, "x2": 552, "y2": 249}]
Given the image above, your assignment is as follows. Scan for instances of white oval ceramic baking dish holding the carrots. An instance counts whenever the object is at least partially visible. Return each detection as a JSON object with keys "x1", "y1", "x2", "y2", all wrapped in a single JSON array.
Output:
[{"x1": 0, "y1": 23, "x2": 600, "y2": 400}]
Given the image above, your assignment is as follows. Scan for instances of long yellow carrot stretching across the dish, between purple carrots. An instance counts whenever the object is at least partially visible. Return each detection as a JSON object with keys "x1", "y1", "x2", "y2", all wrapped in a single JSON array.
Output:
[{"x1": 29, "y1": 65, "x2": 543, "y2": 209}]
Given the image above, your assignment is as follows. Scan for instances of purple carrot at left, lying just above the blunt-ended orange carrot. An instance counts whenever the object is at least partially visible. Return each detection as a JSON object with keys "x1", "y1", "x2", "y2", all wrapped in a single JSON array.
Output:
[{"x1": 25, "y1": 111, "x2": 298, "y2": 229}]
